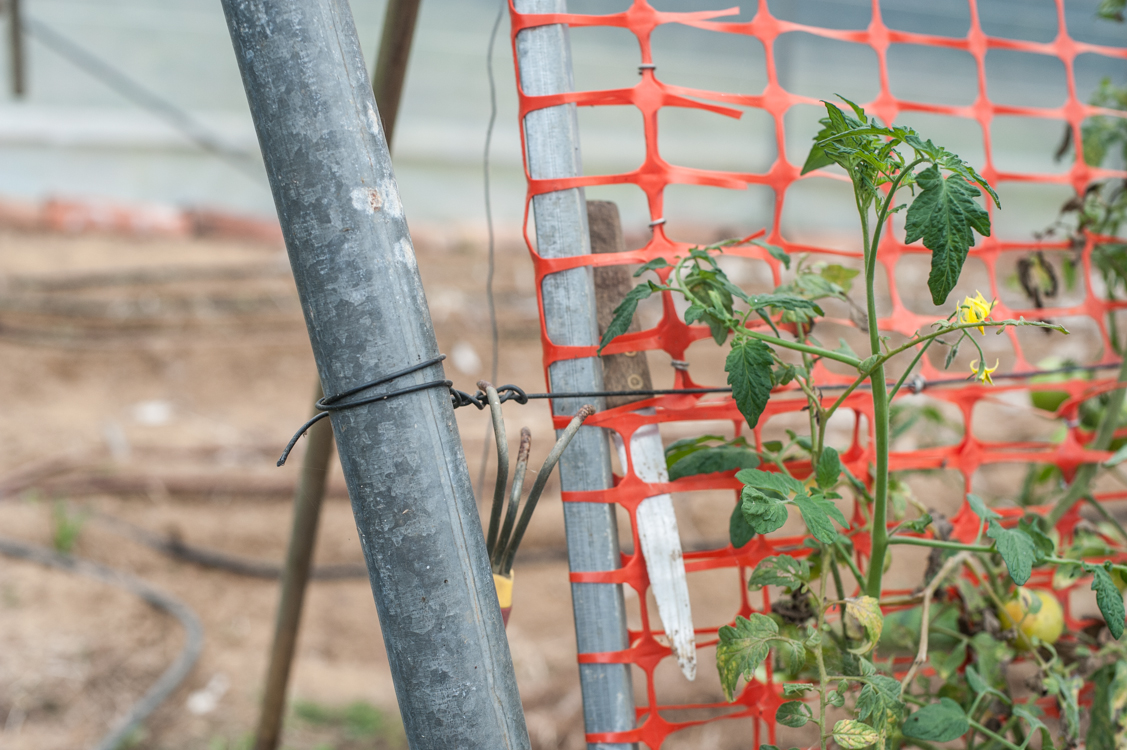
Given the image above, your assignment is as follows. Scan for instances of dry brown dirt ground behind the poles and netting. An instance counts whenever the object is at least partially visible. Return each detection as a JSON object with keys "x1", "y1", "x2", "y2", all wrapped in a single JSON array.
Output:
[{"x1": 0, "y1": 225, "x2": 1108, "y2": 750}]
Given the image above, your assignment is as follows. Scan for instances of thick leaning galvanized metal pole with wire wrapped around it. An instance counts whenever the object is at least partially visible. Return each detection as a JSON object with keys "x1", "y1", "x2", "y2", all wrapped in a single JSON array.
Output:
[{"x1": 223, "y1": 0, "x2": 529, "y2": 750}]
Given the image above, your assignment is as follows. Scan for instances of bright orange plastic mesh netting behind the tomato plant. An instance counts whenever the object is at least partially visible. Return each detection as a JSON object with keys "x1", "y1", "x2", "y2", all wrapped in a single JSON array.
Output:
[{"x1": 511, "y1": 0, "x2": 1127, "y2": 749}]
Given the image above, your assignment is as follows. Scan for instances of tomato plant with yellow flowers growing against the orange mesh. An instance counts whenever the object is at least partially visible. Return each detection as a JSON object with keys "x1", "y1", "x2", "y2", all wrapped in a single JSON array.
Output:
[{"x1": 602, "y1": 100, "x2": 1127, "y2": 750}]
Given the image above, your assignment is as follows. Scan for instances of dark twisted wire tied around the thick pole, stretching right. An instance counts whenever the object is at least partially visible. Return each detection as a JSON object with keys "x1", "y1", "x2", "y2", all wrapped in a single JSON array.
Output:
[{"x1": 277, "y1": 354, "x2": 1120, "y2": 466}]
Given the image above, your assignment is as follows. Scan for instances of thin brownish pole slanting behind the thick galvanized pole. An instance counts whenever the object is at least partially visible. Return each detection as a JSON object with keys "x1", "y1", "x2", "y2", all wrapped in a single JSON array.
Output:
[{"x1": 255, "y1": 0, "x2": 420, "y2": 750}]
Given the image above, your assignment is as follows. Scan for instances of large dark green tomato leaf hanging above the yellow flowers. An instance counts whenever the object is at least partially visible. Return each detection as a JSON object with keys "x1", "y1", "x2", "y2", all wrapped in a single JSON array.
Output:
[{"x1": 904, "y1": 165, "x2": 990, "y2": 305}]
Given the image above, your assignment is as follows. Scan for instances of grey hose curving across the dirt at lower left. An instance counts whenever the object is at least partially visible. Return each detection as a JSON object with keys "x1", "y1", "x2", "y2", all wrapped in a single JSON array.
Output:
[{"x1": 0, "y1": 537, "x2": 204, "y2": 750}]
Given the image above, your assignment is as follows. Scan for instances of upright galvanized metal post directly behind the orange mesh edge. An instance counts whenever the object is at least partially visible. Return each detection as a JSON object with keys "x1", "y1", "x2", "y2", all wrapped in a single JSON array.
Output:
[{"x1": 515, "y1": 0, "x2": 635, "y2": 750}]
